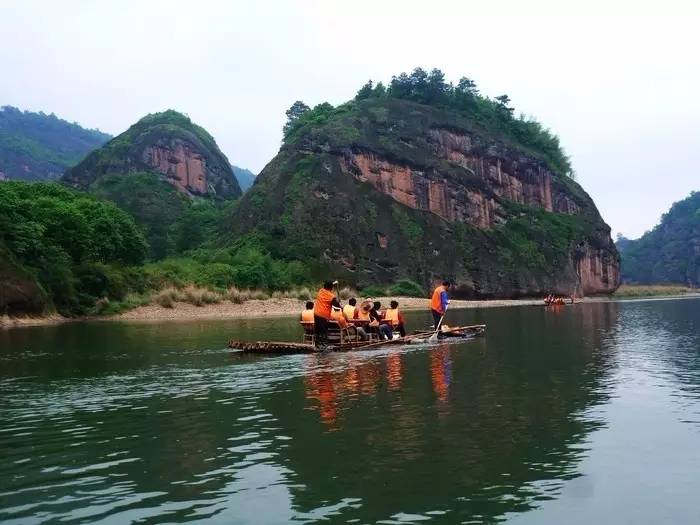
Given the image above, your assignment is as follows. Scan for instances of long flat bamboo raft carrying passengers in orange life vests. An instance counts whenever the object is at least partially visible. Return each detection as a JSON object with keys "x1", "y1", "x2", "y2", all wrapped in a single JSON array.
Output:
[{"x1": 228, "y1": 324, "x2": 486, "y2": 355}]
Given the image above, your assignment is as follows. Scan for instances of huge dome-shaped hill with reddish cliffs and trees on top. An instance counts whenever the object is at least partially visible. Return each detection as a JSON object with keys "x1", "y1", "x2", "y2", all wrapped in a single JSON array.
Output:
[{"x1": 227, "y1": 69, "x2": 619, "y2": 297}]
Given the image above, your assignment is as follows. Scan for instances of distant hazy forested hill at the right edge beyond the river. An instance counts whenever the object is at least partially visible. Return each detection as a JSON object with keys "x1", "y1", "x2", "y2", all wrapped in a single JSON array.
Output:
[{"x1": 617, "y1": 191, "x2": 700, "y2": 287}]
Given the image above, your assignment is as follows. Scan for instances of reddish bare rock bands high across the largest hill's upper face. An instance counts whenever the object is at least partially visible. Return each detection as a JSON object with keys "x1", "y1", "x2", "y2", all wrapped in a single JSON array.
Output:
[{"x1": 341, "y1": 129, "x2": 581, "y2": 228}]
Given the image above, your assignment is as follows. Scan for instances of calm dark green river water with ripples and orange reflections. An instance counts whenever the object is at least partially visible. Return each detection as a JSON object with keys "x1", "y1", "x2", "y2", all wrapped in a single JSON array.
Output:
[{"x1": 0, "y1": 299, "x2": 700, "y2": 524}]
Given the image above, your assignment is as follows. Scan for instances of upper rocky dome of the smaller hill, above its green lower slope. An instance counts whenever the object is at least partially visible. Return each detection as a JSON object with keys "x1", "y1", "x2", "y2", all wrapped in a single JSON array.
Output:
[{"x1": 62, "y1": 111, "x2": 241, "y2": 198}]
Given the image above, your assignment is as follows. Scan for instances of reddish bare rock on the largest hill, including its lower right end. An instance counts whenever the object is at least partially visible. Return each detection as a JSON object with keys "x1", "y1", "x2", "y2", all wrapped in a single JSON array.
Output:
[{"x1": 340, "y1": 125, "x2": 620, "y2": 295}]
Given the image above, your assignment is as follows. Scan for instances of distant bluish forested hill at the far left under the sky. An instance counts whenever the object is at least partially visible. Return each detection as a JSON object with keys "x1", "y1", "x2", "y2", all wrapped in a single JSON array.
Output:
[{"x1": 0, "y1": 106, "x2": 111, "y2": 181}]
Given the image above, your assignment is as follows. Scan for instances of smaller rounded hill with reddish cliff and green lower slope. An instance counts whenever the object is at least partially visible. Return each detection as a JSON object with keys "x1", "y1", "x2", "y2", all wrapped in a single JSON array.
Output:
[{"x1": 61, "y1": 110, "x2": 241, "y2": 259}]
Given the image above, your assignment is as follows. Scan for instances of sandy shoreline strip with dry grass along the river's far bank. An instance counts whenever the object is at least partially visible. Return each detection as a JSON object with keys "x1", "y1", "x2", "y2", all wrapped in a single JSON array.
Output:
[{"x1": 0, "y1": 285, "x2": 700, "y2": 329}]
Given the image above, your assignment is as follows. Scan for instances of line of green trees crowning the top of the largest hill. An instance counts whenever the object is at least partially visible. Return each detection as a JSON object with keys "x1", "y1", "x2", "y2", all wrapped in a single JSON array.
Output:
[{"x1": 284, "y1": 68, "x2": 573, "y2": 176}]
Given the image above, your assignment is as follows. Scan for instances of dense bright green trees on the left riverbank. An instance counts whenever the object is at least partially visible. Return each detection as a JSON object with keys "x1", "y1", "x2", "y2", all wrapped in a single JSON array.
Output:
[{"x1": 0, "y1": 182, "x2": 146, "y2": 314}]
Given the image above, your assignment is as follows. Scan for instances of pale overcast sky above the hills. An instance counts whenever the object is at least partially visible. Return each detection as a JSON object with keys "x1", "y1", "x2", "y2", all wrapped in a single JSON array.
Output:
[{"x1": 0, "y1": 0, "x2": 700, "y2": 238}]
